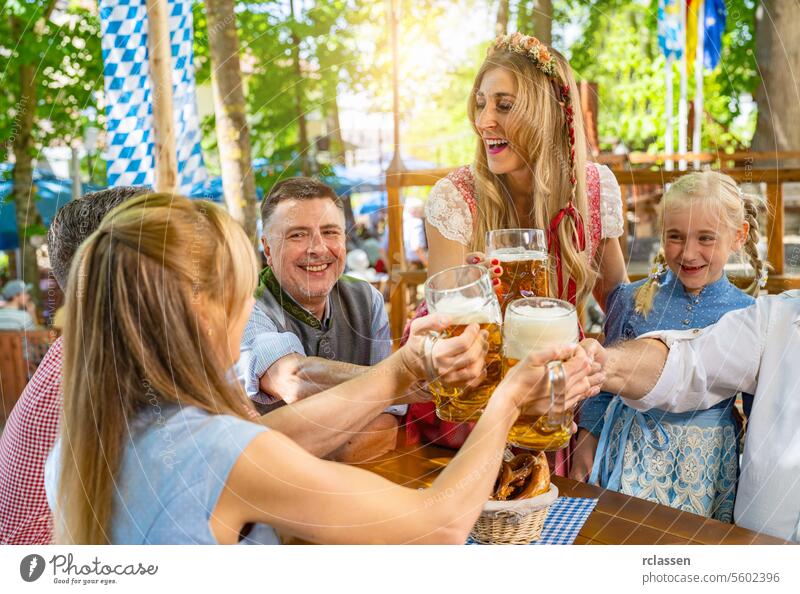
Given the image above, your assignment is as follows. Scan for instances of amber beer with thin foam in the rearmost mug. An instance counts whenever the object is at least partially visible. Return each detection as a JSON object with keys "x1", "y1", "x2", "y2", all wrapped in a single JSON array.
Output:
[{"x1": 489, "y1": 248, "x2": 550, "y2": 311}]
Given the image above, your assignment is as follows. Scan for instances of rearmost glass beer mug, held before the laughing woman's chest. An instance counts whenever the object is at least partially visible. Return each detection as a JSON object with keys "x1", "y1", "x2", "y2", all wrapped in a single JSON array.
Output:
[{"x1": 486, "y1": 229, "x2": 550, "y2": 311}]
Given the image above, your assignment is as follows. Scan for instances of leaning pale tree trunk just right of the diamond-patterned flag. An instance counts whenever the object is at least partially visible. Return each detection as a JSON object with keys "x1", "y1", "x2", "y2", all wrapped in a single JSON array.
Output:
[{"x1": 206, "y1": 0, "x2": 258, "y2": 245}]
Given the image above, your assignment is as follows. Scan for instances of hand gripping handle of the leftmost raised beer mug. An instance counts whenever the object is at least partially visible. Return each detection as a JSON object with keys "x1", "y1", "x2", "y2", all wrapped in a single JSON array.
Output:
[{"x1": 400, "y1": 314, "x2": 489, "y2": 387}]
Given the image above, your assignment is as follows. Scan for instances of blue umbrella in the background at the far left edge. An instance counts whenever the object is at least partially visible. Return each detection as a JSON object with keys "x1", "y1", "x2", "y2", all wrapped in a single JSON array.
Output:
[{"x1": 0, "y1": 163, "x2": 102, "y2": 250}]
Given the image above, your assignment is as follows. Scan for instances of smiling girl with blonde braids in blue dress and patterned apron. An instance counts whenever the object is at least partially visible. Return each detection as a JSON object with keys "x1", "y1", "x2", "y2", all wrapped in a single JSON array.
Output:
[{"x1": 572, "y1": 171, "x2": 766, "y2": 522}]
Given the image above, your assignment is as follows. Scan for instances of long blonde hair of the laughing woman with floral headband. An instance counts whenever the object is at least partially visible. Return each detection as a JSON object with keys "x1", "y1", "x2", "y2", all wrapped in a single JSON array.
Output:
[{"x1": 467, "y1": 46, "x2": 596, "y2": 303}]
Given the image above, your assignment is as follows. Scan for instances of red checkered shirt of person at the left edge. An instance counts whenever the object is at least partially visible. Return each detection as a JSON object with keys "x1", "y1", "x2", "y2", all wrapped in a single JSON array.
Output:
[{"x1": 0, "y1": 338, "x2": 62, "y2": 544}]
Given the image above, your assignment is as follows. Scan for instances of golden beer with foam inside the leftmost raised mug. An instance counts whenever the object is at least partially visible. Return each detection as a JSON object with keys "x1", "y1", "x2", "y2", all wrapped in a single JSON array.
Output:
[{"x1": 430, "y1": 295, "x2": 502, "y2": 423}]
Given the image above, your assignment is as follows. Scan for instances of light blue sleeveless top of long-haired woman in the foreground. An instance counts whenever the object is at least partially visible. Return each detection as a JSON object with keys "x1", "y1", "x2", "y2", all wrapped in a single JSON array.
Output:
[{"x1": 45, "y1": 405, "x2": 280, "y2": 544}]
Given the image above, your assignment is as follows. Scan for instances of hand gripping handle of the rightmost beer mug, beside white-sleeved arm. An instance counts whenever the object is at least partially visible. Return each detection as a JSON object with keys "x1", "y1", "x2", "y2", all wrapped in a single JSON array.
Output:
[{"x1": 495, "y1": 345, "x2": 605, "y2": 416}]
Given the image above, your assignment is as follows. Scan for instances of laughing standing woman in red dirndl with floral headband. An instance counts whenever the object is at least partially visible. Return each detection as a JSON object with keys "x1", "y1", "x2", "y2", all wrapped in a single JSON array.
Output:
[{"x1": 407, "y1": 33, "x2": 627, "y2": 462}]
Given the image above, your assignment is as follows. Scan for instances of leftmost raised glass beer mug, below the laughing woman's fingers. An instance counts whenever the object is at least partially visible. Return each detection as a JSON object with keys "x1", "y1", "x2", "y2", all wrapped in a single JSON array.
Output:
[{"x1": 425, "y1": 265, "x2": 502, "y2": 423}]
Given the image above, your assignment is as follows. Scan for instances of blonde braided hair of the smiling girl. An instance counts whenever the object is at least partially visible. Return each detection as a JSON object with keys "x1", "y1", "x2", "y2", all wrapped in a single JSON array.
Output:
[{"x1": 634, "y1": 171, "x2": 768, "y2": 318}]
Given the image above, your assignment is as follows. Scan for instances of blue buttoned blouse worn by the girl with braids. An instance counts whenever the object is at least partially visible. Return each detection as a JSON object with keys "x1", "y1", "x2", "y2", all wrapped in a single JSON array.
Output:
[{"x1": 579, "y1": 270, "x2": 755, "y2": 436}]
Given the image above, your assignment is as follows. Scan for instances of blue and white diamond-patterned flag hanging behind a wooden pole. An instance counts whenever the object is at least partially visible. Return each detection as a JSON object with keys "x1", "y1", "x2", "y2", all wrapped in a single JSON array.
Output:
[{"x1": 100, "y1": 0, "x2": 206, "y2": 194}]
